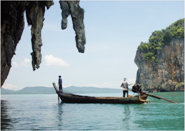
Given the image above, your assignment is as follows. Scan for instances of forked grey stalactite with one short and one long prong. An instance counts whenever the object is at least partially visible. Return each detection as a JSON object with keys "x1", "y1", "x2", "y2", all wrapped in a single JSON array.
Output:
[{"x1": 60, "y1": 1, "x2": 86, "y2": 53}]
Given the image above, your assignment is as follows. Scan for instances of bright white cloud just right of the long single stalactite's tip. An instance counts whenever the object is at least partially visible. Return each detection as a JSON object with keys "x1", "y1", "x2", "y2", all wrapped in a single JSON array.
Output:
[{"x1": 44, "y1": 54, "x2": 69, "y2": 67}]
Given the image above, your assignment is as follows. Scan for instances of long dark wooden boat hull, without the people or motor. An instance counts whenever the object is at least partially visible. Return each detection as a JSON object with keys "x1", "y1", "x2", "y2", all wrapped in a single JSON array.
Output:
[{"x1": 58, "y1": 93, "x2": 147, "y2": 104}]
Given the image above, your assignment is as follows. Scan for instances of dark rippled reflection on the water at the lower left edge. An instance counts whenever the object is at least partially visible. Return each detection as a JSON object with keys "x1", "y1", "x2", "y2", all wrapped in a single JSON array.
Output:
[{"x1": 1, "y1": 100, "x2": 13, "y2": 130}]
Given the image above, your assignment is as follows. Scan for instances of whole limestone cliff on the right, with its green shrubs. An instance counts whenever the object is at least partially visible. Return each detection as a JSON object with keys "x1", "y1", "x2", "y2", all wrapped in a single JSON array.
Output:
[{"x1": 135, "y1": 19, "x2": 184, "y2": 91}]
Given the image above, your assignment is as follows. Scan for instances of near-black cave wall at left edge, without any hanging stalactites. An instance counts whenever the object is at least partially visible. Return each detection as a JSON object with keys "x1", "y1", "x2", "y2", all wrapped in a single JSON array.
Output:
[{"x1": 1, "y1": 1, "x2": 28, "y2": 86}]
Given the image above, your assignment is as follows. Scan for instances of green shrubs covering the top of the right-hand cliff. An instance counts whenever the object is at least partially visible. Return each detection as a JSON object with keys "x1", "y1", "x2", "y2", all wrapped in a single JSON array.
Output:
[{"x1": 138, "y1": 19, "x2": 184, "y2": 65}]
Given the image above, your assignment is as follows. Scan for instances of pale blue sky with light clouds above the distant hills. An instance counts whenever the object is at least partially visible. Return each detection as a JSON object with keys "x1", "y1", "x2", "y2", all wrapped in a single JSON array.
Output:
[{"x1": 2, "y1": 0, "x2": 184, "y2": 90}]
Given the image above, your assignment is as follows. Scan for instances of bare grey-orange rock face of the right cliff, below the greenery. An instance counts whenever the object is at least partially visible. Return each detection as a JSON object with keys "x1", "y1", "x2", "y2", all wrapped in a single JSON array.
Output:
[{"x1": 135, "y1": 39, "x2": 184, "y2": 91}]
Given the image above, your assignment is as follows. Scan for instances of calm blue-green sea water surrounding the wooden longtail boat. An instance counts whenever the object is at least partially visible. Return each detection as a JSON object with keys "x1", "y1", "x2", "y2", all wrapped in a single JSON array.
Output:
[{"x1": 1, "y1": 92, "x2": 184, "y2": 130}]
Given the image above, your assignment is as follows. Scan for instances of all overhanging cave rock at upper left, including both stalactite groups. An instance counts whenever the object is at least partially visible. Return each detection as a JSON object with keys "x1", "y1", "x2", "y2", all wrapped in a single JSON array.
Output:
[{"x1": 1, "y1": 0, "x2": 86, "y2": 86}]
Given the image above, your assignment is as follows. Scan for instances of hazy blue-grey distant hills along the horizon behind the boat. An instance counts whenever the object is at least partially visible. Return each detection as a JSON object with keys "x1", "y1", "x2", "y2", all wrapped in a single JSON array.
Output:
[{"x1": 1, "y1": 86, "x2": 122, "y2": 95}]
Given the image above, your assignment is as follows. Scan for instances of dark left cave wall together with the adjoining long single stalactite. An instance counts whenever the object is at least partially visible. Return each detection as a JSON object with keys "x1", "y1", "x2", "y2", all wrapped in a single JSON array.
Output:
[{"x1": 1, "y1": 1, "x2": 53, "y2": 86}]
